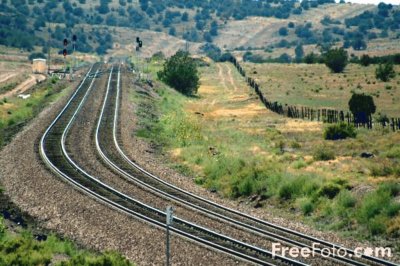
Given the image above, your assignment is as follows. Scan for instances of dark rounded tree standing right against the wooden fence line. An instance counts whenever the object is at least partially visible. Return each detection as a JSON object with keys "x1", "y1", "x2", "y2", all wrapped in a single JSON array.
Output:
[{"x1": 349, "y1": 93, "x2": 376, "y2": 123}]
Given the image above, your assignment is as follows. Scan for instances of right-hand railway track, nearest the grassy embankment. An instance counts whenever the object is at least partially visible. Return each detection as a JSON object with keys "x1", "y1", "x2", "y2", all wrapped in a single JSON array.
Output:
[{"x1": 95, "y1": 64, "x2": 397, "y2": 266}]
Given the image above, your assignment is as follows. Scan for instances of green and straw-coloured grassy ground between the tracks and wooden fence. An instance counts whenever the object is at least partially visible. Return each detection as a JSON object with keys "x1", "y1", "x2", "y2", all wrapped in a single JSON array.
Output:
[{"x1": 132, "y1": 58, "x2": 400, "y2": 243}]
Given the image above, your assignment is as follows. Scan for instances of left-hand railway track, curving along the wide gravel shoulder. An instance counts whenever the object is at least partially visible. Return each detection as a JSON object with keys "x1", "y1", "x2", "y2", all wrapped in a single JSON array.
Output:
[{"x1": 39, "y1": 64, "x2": 306, "y2": 265}]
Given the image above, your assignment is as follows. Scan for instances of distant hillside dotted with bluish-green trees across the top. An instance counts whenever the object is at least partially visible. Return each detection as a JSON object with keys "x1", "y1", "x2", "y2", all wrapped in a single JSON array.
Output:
[{"x1": 0, "y1": 0, "x2": 400, "y2": 57}]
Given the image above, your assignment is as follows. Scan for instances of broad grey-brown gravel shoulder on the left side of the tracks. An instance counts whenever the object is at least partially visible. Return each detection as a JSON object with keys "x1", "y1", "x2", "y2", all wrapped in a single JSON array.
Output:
[{"x1": 0, "y1": 69, "x2": 243, "y2": 265}]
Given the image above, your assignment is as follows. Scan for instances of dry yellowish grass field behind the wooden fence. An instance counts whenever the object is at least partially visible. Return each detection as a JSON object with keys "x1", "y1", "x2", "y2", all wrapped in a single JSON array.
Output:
[{"x1": 243, "y1": 63, "x2": 400, "y2": 117}]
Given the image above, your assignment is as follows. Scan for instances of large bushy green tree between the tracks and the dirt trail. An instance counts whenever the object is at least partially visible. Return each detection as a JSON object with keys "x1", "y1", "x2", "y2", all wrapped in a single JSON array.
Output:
[{"x1": 157, "y1": 51, "x2": 200, "y2": 95}]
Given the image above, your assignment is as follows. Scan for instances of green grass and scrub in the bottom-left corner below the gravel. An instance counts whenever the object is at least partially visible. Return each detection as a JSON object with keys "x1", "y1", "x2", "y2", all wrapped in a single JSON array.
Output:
[{"x1": 0, "y1": 216, "x2": 132, "y2": 266}]
